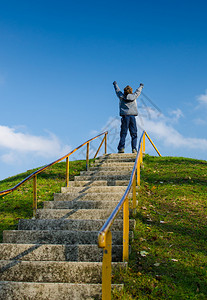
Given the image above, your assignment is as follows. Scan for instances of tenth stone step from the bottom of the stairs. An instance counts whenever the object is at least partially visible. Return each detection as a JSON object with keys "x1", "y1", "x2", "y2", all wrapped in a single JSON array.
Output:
[{"x1": 69, "y1": 180, "x2": 129, "y2": 187}]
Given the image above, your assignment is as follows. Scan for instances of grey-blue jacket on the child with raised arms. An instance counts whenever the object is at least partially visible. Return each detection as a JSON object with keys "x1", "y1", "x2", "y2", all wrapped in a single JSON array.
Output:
[{"x1": 114, "y1": 83, "x2": 143, "y2": 116}]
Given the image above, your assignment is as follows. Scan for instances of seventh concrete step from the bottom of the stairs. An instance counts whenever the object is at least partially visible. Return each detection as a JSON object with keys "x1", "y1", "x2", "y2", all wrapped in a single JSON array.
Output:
[{"x1": 44, "y1": 200, "x2": 119, "y2": 210}]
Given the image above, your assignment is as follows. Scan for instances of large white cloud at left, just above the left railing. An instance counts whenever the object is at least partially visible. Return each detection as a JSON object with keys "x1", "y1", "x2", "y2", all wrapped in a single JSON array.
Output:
[{"x1": 0, "y1": 126, "x2": 71, "y2": 163}]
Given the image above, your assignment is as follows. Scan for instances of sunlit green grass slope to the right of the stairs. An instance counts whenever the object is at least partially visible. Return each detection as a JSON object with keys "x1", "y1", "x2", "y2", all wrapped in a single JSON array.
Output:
[{"x1": 113, "y1": 155, "x2": 207, "y2": 300}]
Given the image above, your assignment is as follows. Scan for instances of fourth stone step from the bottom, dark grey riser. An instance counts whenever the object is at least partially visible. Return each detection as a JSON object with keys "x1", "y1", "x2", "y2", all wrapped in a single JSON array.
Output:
[{"x1": 3, "y1": 230, "x2": 129, "y2": 245}]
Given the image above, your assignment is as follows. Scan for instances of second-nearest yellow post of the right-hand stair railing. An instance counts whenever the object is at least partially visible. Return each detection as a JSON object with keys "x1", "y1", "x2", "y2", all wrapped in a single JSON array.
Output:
[{"x1": 123, "y1": 197, "x2": 129, "y2": 262}]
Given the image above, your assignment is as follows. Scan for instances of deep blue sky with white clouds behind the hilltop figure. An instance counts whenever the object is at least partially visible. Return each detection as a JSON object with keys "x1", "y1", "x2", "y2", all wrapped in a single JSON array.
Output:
[{"x1": 0, "y1": 0, "x2": 207, "y2": 179}]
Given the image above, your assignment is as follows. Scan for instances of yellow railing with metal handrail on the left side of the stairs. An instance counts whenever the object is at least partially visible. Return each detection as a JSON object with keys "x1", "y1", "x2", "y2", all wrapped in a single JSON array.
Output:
[{"x1": 0, "y1": 131, "x2": 108, "y2": 216}]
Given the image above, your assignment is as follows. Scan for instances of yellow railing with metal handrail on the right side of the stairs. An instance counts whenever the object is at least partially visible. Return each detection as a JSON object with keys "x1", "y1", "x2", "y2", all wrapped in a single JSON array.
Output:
[{"x1": 98, "y1": 131, "x2": 161, "y2": 300}]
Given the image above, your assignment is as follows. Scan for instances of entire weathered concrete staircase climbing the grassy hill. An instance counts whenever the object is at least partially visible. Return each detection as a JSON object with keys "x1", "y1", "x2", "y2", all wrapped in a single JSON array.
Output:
[{"x1": 0, "y1": 154, "x2": 135, "y2": 300}]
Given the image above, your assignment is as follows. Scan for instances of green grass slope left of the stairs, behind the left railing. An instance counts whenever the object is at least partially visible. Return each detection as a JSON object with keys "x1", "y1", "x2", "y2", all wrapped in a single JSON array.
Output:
[{"x1": 0, "y1": 160, "x2": 86, "y2": 242}]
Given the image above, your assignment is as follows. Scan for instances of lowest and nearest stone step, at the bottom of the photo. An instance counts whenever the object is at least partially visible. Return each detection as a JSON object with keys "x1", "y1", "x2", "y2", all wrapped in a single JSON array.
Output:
[{"x1": 0, "y1": 281, "x2": 123, "y2": 300}]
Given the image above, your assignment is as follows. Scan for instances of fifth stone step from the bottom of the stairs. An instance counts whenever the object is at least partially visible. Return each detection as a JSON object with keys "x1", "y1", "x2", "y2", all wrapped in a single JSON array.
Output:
[{"x1": 18, "y1": 219, "x2": 136, "y2": 232}]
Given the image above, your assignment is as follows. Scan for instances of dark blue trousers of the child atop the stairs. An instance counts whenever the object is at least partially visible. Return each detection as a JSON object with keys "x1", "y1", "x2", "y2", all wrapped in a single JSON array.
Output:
[{"x1": 118, "y1": 116, "x2": 137, "y2": 150}]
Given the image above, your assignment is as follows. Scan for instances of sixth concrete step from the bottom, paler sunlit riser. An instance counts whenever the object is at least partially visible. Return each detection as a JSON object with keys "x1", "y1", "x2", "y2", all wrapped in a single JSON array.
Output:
[{"x1": 36, "y1": 209, "x2": 122, "y2": 220}]
